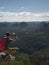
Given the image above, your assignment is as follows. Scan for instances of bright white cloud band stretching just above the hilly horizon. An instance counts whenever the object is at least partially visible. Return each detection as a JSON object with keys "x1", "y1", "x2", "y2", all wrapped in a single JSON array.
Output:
[{"x1": 0, "y1": 11, "x2": 49, "y2": 22}]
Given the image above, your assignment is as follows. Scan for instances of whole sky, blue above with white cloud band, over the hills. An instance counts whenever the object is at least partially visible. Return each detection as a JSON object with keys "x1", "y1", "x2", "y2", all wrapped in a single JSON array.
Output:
[{"x1": 0, "y1": 0, "x2": 49, "y2": 22}]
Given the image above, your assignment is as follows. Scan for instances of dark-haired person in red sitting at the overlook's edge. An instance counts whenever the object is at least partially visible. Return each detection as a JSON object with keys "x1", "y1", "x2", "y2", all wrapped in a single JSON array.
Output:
[{"x1": 0, "y1": 32, "x2": 18, "y2": 59}]
